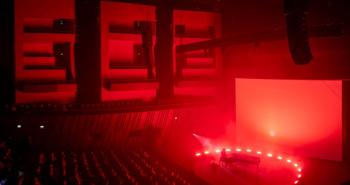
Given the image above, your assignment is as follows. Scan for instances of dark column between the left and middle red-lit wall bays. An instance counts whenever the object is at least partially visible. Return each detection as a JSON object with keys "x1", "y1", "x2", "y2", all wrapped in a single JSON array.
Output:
[{"x1": 75, "y1": 0, "x2": 102, "y2": 103}]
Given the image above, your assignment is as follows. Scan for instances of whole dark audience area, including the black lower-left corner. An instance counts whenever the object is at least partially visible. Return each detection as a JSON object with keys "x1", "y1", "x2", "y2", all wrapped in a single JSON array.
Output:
[{"x1": 0, "y1": 138, "x2": 207, "y2": 185}]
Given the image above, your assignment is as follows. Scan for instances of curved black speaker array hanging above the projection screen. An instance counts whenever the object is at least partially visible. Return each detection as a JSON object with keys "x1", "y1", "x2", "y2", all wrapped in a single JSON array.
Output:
[{"x1": 284, "y1": 0, "x2": 313, "y2": 64}]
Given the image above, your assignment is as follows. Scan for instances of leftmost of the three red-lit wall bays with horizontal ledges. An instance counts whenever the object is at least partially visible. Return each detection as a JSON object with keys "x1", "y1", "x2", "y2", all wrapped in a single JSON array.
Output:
[{"x1": 15, "y1": 0, "x2": 76, "y2": 103}]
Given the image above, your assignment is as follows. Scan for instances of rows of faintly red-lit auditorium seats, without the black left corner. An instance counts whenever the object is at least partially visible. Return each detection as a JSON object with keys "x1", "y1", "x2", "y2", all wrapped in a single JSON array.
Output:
[{"x1": 18, "y1": 150, "x2": 207, "y2": 185}]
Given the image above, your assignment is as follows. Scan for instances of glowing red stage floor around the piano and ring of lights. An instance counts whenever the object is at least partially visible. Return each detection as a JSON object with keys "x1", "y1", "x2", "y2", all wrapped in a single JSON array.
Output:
[{"x1": 194, "y1": 158, "x2": 350, "y2": 185}]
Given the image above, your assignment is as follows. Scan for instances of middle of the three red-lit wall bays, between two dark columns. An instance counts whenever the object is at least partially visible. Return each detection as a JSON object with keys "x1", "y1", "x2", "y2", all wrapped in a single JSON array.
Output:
[{"x1": 101, "y1": 2, "x2": 158, "y2": 101}]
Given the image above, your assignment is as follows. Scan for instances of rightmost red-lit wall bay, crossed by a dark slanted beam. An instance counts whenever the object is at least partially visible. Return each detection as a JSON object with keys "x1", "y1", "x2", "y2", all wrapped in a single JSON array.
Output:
[{"x1": 174, "y1": 10, "x2": 222, "y2": 96}]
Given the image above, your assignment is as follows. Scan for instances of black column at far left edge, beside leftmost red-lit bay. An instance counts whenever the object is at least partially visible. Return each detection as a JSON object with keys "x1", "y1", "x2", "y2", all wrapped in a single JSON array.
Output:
[{"x1": 0, "y1": 0, "x2": 16, "y2": 108}]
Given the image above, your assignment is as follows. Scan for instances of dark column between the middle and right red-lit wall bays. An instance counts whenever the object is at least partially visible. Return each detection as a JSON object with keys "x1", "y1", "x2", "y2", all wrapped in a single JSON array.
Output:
[{"x1": 155, "y1": 0, "x2": 174, "y2": 99}]
